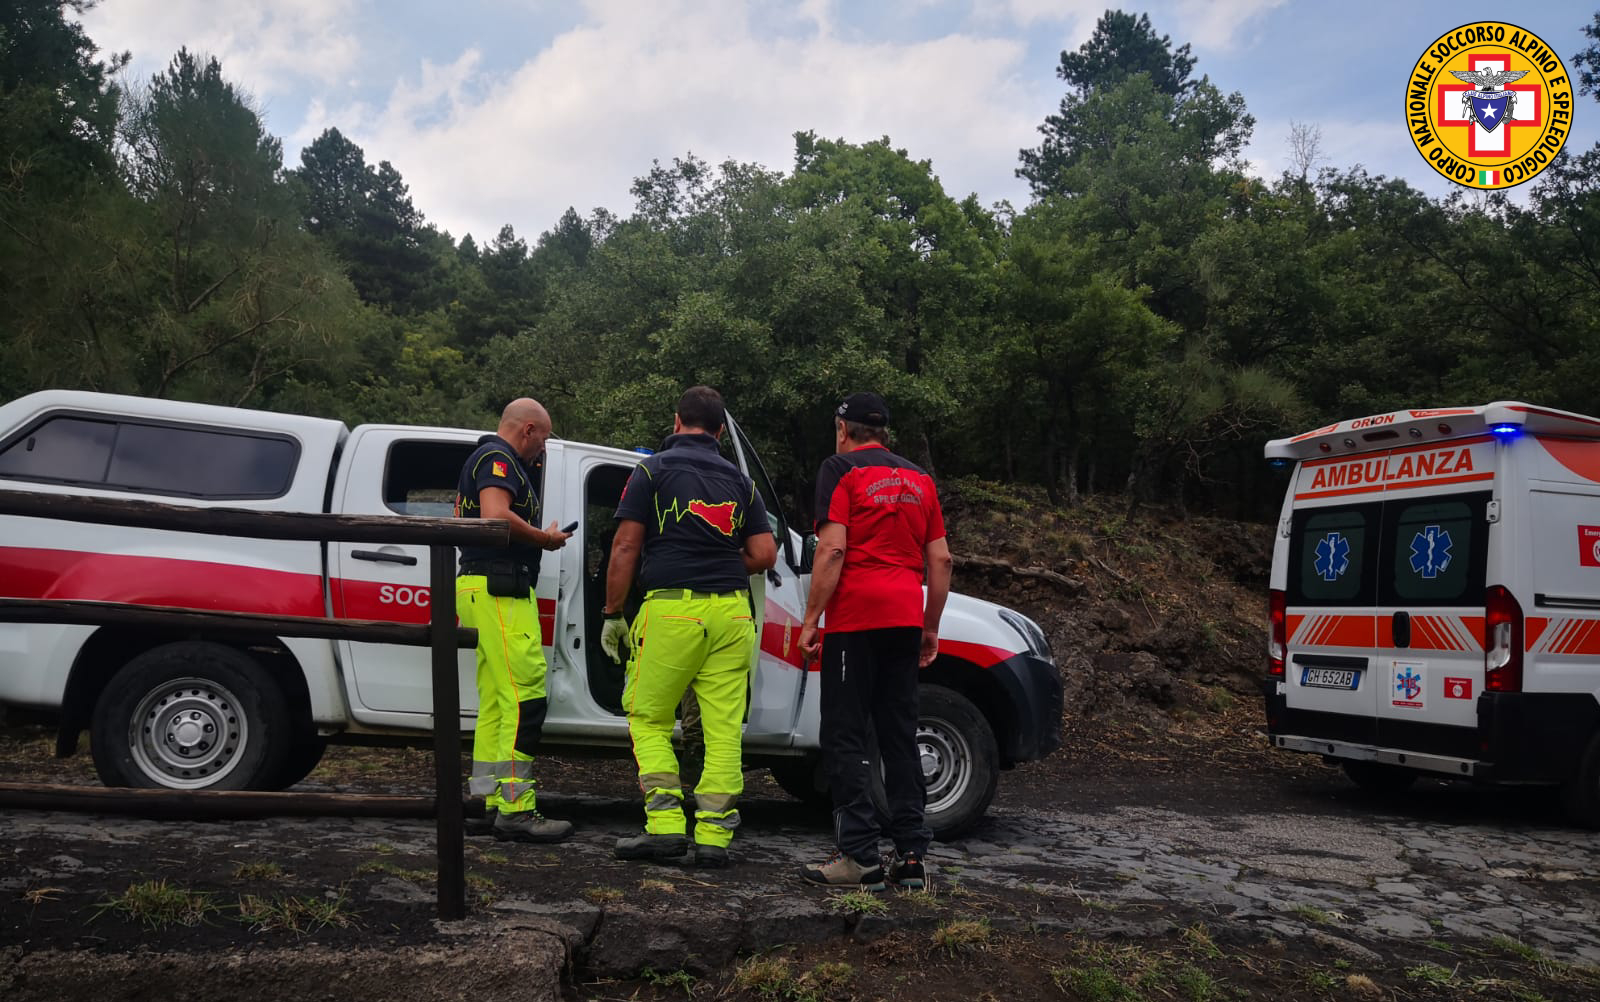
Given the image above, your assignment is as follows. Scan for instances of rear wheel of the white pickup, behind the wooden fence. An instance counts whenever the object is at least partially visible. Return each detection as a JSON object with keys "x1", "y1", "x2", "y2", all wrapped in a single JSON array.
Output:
[{"x1": 90, "y1": 640, "x2": 294, "y2": 789}]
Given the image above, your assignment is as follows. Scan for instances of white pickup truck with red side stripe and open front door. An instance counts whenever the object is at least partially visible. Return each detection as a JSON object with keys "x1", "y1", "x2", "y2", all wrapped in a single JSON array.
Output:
[{"x1": 0, "y1": 391, "x2": 1062, "y2": 836}]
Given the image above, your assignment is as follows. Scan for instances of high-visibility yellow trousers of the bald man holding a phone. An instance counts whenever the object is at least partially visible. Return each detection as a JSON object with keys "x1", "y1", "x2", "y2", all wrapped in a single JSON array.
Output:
[{"x1": 456, "y1": 575, "x2": 547, "y2": 815}]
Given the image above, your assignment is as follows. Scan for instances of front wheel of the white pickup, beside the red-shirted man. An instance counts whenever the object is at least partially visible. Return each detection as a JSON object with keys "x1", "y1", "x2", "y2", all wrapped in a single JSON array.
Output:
[{"x1": 917, "y1": 685, "x2": 1000, "y2": 840}]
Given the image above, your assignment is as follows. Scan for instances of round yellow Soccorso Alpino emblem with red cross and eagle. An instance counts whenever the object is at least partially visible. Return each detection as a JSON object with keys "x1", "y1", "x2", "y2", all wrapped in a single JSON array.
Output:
[{"x1": 1405, "y1": 21, "x2": 1573, "y2": 189}]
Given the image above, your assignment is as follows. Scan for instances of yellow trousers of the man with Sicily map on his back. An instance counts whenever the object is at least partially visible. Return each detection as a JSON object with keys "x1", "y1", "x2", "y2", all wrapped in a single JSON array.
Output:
[{"x1": 622, "y1": 589, "x2": 755, "y2": 847}]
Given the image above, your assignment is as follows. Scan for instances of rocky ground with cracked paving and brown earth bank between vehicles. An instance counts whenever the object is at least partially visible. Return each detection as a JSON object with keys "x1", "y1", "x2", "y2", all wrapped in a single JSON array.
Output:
[{"x1": 0, "y1": 496, "x2": 1600, "y2": 1002}]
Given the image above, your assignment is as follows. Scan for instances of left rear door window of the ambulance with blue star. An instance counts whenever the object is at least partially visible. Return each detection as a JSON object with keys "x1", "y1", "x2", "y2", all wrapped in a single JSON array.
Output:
[{"x1": 1288, "y1": 504, "x2": 1381, "y2": 605}]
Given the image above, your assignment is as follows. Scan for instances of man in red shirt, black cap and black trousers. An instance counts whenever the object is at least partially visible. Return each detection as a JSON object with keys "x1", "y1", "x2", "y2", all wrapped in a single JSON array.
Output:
[{"x1": 800, "y1": 394, "x2": 952, "y2": 892}]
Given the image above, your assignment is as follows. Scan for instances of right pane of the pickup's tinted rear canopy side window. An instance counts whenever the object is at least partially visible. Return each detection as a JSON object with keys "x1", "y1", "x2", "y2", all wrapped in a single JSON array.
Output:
[{"x1": 106, "y1": 423, "x2": 299, "y2": 499}]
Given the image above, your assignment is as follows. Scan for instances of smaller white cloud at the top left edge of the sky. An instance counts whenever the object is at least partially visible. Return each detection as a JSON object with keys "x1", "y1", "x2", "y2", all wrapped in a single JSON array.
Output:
[{"x1": 83, "y1": 0, "x2": 362, "y2": 96}]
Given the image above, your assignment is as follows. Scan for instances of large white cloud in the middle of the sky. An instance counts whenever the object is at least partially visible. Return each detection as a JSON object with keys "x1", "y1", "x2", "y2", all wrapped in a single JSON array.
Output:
[{"x1": 331, "y1": 0, "x2": 1054, "y2": 240}]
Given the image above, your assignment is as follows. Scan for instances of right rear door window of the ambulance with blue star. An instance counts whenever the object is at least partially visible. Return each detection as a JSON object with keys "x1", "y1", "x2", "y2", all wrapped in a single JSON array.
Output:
[{"x1": 1381, "y1": 493, "x2": 1488, "y2": 605}]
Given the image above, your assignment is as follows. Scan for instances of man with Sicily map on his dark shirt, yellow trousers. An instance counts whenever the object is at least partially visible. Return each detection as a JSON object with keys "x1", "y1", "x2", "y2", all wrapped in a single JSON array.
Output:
[{"x1": 600, "y1": 386, "x2": 778, "y2": 866}]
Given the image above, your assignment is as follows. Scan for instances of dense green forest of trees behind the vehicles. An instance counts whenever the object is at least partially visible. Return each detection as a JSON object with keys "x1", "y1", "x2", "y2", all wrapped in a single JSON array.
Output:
[{"x1": 0, "y1": 7, "x2": 1600, "y2": 515}]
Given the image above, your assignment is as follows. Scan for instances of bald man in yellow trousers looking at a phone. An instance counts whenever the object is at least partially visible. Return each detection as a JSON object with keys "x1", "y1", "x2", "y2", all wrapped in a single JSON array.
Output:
[{"x1": 456, "y1": 397, "x2": 573, "y2": 842}]
